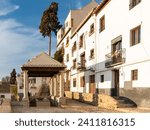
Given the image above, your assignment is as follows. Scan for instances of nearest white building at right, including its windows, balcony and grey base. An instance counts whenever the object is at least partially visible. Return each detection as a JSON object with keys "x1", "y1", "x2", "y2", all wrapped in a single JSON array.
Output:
[{"x1": 95, "y1": 0, "x2": 150, "y2": 106}]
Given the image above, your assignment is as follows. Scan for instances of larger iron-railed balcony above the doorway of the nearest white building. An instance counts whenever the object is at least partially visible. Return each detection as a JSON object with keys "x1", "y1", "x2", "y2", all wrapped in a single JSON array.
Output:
[{"x1": 105, "y1": 49, "x2": 126, "y2": 68}]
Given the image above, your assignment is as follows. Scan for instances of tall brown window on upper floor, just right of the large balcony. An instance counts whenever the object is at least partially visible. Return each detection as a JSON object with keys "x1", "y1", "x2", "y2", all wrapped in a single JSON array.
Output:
[{"x1": 130, "y1": 26, "x2": 141, "y2": 46}]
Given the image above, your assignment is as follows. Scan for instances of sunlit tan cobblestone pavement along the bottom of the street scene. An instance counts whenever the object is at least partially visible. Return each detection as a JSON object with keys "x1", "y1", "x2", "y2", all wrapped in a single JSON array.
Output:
[{"x1": 12, "y1": 100, "x2": 150, "y2": 113}]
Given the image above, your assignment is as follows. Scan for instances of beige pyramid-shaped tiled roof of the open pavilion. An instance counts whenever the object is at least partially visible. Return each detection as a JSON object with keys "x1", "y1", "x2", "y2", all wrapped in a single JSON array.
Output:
[{"x1": 22, "y1": 52, "x2": 65, "y2": 68}]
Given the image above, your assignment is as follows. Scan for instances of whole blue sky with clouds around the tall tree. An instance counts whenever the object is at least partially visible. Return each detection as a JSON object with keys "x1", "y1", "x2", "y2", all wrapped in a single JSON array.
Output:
[{"x1": 0, "y1": 0, "x2": 101, "y2": 79}]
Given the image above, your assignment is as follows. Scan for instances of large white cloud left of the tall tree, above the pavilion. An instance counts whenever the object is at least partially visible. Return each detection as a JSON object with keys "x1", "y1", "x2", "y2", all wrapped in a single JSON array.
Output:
[{"x1": 0, "y1": 19, "x2": 56, "y2": 78}]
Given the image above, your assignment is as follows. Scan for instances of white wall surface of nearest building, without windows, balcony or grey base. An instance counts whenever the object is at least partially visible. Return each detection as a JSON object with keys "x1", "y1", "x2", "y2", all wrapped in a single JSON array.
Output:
[{"x1": 96, "y1": 0, "x2": 150, "y2": 88}]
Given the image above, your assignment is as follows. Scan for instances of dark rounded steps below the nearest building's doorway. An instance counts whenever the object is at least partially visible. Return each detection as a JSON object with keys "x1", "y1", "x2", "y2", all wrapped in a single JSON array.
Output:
[{"x1": 113, "y1": 96, "x2": 137, "y2": 108}]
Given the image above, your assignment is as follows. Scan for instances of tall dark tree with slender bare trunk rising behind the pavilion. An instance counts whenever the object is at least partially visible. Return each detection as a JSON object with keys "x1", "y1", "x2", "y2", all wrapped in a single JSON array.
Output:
[{"x1": 39, "y1": 2, "x2": 62, "y2": 56}]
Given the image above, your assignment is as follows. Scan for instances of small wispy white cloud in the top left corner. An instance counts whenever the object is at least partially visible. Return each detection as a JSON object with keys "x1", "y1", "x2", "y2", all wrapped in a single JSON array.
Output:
[{"x1": 0, "y1": 0, "x2": 19, "y2": 16}]
